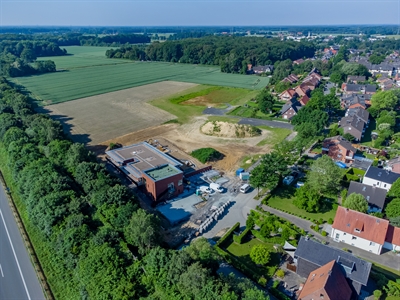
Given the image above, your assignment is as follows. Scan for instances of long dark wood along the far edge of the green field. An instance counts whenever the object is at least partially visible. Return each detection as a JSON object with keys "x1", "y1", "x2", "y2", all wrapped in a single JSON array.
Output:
[{"x1": 106, "y1": 36, "x2": 316, "y2": 73}]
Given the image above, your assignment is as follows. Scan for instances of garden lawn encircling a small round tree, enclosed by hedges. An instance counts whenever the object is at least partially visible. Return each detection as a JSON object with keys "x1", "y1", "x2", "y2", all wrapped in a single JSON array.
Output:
[{"x1": 226, "y1": 239, "x2": 280, "y2": 278}]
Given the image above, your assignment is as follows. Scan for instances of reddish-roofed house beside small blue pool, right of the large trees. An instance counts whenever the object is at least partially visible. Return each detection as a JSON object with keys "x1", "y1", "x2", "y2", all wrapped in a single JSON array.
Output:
[{"x1": 322, "y1": 135, "x2": 357, "y2": 164}]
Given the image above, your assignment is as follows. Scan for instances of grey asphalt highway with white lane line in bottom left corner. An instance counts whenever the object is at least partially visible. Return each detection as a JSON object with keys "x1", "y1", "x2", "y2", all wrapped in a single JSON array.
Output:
[{"x1": 0, "y1": 186, "x2": 45, "y2": 300}]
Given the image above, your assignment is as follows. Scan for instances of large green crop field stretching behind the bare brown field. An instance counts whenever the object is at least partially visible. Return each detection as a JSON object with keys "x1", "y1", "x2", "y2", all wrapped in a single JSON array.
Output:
[{"x1": 13, "y1": 47, "x2": 269, "y2": 105}]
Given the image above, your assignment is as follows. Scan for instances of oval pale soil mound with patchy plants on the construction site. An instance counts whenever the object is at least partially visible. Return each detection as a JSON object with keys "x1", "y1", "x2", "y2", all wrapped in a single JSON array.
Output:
[{"x1": 201, "y1": 121, "x2": 261, "y2": 138}]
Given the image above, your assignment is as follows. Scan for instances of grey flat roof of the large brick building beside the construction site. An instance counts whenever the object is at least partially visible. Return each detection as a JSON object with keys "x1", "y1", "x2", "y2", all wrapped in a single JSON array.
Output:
[{"x1": 106, "y1": 142, "x2": 182, "y2": 172}]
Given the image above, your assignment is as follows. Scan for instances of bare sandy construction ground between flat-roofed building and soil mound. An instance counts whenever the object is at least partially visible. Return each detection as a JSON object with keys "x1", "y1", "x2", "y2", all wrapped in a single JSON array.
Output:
[{"x1": 98, "y1": 116, "x2": 270, "y2": 174}]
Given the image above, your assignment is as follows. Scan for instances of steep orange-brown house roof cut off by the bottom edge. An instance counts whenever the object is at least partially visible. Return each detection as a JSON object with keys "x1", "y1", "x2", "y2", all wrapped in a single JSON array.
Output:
[{"x1": 298, "y1": 260, "x2": 353, "y2": 300}]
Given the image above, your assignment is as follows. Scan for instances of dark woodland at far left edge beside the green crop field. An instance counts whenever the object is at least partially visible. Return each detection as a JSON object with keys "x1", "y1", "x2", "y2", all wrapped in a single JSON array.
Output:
[{"x1": 0, "y1": 40, "x2": 63, "y2": 77}]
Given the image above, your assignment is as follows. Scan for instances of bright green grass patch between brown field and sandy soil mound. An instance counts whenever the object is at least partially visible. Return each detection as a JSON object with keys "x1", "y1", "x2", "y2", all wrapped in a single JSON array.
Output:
[{"x1": 149, "y1": 85, "x2": 253, "y2": 124}]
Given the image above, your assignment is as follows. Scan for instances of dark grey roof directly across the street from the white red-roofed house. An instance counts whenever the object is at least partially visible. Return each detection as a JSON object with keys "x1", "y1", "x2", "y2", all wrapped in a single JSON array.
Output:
[{"x1": 294, "y1": 237, "x2": 372, "y2": 286}]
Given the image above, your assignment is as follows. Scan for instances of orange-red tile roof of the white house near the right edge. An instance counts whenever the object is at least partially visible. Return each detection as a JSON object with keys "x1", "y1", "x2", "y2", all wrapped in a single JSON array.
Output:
[{"x1": 332, "y1": 206, "x2": 389, "y2": 245}]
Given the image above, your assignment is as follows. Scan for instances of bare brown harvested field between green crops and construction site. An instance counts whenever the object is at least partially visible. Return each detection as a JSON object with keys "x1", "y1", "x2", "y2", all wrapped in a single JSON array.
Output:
[{"x1": 39, "y1": 81, "x2": 197, "y2": 145}]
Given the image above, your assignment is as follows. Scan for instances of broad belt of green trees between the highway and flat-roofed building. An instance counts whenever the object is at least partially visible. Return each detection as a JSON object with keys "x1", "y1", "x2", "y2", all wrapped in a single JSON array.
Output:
[{"x1": 0, "y1": 78, "x2": 268, "y2": 300}]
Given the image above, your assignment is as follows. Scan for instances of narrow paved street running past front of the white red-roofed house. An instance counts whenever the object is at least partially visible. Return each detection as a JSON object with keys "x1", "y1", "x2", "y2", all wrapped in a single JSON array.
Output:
[{"x1": 261, "y1": 204, "x2": 400, "y2": 271}]
